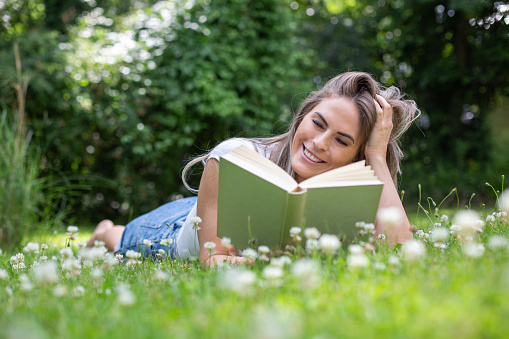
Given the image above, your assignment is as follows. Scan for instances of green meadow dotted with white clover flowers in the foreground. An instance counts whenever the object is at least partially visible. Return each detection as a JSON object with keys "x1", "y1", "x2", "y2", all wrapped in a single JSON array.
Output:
[{"x1": 0, "y1": 198, "x2": 509, "y2": 338}]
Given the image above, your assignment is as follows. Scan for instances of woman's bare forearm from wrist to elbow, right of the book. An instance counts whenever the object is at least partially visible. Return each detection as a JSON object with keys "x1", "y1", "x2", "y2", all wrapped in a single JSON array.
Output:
[{"x1": 367, "y1": 157, "x2": 413, "y2": 245}]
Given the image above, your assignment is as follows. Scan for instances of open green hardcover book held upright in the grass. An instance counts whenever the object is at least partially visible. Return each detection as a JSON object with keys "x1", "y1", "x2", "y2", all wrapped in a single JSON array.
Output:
[{"x1": 217, "y1": 146, "x2": 383, "y2": 249}]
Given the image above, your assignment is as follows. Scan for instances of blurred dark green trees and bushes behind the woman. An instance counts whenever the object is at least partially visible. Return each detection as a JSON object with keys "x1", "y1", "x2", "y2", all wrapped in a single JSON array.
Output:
[{"x1": 0, "y1": 0, "x2": 509, "y2": 246}]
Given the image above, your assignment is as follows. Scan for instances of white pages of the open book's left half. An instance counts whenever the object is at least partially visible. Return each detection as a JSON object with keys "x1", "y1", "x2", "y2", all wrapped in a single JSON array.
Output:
[{"x1": 223, "y1": 146, "x2": 298, "y2": 191}]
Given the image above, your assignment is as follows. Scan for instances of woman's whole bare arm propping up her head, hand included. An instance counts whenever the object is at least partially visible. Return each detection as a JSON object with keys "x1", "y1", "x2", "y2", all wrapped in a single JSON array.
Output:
[{"x1": 365, "y1": 95, "x2": 413, "y2": 245}]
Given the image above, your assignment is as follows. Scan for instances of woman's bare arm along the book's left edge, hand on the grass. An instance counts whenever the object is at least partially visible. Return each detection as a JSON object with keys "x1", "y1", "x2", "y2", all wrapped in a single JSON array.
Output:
[{"x1": 197, "y1": 159, "x2": 244, "y2": 265}]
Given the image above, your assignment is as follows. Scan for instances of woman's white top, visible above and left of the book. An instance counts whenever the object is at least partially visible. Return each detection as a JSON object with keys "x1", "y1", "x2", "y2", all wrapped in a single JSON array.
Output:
[{"x1": 176, "y1": 138, "x2": 270, "y2": 259}]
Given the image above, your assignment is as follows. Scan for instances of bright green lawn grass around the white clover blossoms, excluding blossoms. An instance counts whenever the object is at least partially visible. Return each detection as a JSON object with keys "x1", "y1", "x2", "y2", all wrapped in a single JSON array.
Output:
[{"x1": 0, "y1": 209, "x2": 509, "y2": 338}]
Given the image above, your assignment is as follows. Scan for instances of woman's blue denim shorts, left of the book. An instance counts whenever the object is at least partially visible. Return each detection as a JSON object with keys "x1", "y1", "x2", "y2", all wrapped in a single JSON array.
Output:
[{"x1": 120, "y1": 197, "x2": 197, "y2": 259}]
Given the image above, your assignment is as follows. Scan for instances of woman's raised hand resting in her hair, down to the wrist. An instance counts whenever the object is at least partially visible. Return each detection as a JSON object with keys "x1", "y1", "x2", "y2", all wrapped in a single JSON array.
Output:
[{"x1": 364, "y1": 94, "x2": 393, "y2": 162}]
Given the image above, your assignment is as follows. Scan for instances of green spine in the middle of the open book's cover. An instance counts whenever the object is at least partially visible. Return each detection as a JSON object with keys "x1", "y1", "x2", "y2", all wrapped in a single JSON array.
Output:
[{"x1": 280, "y1": 189, "x2": 307, "y2": 249}]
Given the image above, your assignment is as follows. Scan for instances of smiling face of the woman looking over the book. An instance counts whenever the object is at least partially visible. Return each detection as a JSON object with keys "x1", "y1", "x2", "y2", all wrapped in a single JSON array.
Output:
[{"x1": 291, "y1": 97, "x2": 361, "y2": 182}]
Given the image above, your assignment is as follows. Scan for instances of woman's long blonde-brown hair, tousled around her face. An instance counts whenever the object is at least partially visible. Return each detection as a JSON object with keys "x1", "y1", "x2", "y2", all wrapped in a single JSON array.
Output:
[{"x1": 182, "y1": 72, "x2": 420, "y2": 192}]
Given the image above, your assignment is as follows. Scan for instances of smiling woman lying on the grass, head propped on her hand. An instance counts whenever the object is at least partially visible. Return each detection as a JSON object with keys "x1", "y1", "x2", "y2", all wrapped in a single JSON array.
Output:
[{"x1": 88, "y1": 72, "x2": 419, "y2": 264}]
